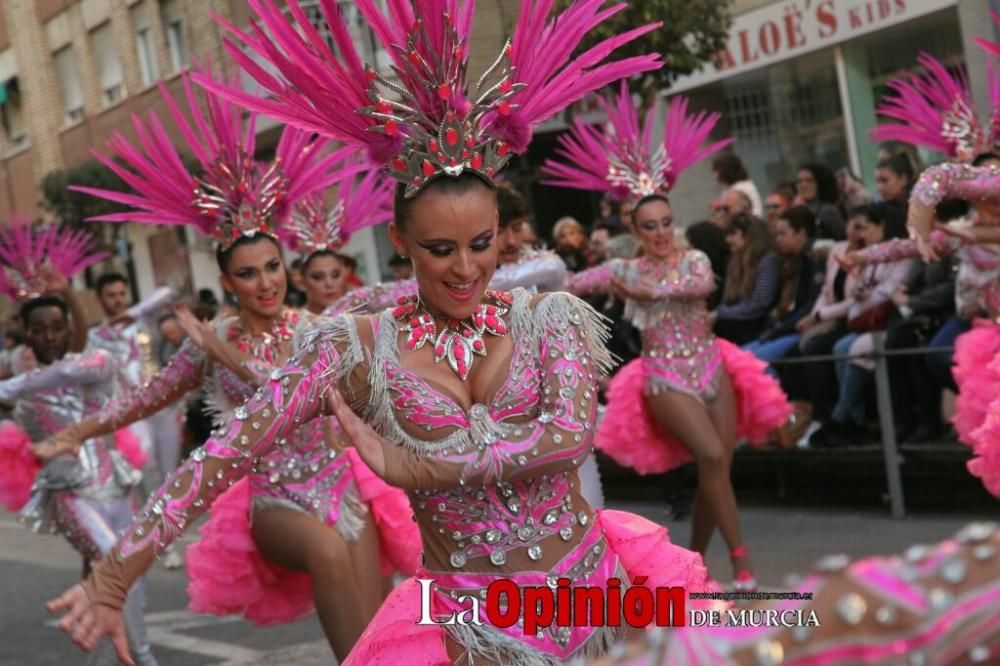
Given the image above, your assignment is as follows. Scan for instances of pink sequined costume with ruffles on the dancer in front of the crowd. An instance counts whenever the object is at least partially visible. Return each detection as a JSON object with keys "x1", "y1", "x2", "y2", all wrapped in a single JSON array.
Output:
[{"x1": 567, "y1": 250, "x2": 791, "y2": 474}]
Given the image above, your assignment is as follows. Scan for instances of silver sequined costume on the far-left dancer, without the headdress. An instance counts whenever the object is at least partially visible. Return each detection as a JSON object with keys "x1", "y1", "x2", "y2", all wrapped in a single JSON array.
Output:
[{"x1": 0, "y1": 350, "x2": 156, "y2": 665}]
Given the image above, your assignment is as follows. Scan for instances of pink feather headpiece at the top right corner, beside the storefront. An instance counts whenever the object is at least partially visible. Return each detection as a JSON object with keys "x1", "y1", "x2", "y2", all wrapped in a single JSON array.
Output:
[{"x1": 871, "y1": 53, "x2": 1000, "y2": 162}]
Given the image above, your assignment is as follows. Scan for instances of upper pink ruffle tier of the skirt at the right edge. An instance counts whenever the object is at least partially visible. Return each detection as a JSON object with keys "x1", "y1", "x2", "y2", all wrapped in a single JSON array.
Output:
[{"x1": 951, "y1": 321, "x2": 1000, "y2": 446}]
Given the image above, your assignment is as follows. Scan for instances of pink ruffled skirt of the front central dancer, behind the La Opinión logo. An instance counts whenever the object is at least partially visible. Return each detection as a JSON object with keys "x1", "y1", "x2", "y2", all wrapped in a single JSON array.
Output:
[{"x1": 344, "y1": 510, "x2": 719, "y2": 666}]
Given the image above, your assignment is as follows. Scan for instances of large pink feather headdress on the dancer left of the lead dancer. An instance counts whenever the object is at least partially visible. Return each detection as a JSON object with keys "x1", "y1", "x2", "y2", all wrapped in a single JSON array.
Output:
[{"x1": 70, "y1": 66, "x2": 337, "y2": 248}]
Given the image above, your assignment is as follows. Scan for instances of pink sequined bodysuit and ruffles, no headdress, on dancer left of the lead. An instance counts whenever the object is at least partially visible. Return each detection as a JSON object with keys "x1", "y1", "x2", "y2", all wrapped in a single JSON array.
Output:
[{"x1": 94, "y1": 310, "x2": 419, "y2": 625}]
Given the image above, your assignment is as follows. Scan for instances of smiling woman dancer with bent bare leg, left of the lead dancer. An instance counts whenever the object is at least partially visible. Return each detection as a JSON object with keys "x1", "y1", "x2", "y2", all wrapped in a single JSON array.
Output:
[{"x1": 44, "y1": 70, "x2": 419, "y2": 659}]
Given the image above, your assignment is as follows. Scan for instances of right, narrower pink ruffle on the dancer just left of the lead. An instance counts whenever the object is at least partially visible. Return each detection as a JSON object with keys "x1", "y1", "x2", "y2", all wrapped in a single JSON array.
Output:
[{"x1": 347, "y1": 446, "x2": 422, "y2": 576}]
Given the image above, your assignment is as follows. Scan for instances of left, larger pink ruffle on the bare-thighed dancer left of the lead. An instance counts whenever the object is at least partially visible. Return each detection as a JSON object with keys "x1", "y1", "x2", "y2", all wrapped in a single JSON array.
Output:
[{"x1": 185, "y1": 479, "x2": 314, "y2": 626}]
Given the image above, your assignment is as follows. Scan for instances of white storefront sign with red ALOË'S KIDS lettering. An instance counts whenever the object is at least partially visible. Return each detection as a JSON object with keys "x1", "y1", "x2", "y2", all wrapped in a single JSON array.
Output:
[{"x1": 670, "y1": 0, "x2": 958, "y2": 93}]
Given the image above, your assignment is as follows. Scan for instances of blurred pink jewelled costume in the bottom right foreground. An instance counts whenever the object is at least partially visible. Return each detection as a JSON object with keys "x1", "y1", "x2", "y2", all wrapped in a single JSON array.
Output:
[{"x1": 576, "y1": 523, "x2": 1000, "y2": 666}]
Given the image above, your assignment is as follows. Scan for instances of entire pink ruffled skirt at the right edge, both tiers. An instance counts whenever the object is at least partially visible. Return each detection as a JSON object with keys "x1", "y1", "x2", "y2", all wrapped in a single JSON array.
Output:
[{"x1": 952, "y1": 321, "x2": 1000, "y2": 497}]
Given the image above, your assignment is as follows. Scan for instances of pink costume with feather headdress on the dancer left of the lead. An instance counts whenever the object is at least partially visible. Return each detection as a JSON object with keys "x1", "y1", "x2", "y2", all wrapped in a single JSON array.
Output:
[{"x1": 66, "y1": 76, "x2": 419, "y2": 625}]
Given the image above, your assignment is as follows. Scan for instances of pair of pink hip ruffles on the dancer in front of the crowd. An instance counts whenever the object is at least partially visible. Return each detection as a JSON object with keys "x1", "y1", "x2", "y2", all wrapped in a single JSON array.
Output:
[{"x1": 596, "y1": 340, "x2": 792, "y2": 474}]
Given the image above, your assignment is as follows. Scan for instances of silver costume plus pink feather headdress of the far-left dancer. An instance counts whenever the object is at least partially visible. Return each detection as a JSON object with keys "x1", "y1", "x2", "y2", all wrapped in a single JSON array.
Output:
[{"x1": 0, "y1": 223, "x2": 156, "y2": 665}]
